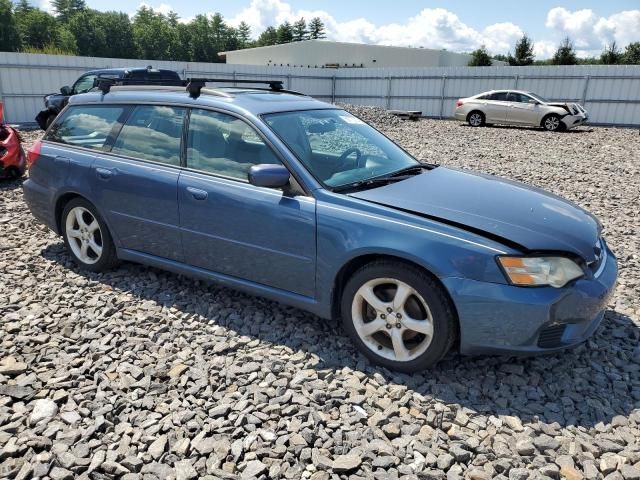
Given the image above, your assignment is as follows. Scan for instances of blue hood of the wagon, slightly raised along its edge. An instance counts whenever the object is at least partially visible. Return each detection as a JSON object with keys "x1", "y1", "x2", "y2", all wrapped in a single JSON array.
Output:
[{"x1": 349, "y1": 167, "x2": 600, "y2": 262}]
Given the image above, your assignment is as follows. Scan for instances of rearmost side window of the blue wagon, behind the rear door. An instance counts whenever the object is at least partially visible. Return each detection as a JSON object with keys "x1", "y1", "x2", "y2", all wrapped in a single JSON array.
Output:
[{"x1": 45, "y1": 105, "x2": 127, "y2": 150}]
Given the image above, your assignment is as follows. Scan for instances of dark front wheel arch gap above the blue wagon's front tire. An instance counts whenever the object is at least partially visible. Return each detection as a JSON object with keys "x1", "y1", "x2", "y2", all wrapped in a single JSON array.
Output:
[{"x1": 331, "y1": 253, "x2": 460, "y2": 348}]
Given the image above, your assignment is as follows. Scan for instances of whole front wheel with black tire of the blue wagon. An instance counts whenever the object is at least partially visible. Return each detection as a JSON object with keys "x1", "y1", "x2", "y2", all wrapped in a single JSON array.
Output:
[{"x1": 341, "y1": 260, "x2": 457, "y2": 373}]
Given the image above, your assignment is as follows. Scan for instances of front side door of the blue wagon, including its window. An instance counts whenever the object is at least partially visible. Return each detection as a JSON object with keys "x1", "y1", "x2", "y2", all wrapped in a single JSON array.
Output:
[{"x1": 178, "y1": 109, "x2": 316, "y2": 297}]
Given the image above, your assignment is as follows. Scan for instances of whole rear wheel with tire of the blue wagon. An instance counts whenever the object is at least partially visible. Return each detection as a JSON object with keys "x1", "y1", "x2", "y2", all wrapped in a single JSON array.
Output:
[{"x1": 60, "y1": 198, "x2": 118, "y2": 272}]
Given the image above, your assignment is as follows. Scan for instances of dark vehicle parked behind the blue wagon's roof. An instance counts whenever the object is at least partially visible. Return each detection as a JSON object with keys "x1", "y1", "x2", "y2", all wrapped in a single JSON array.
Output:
[{"x1": 36, "y1": 66, "x2": 182, "y2": 130}]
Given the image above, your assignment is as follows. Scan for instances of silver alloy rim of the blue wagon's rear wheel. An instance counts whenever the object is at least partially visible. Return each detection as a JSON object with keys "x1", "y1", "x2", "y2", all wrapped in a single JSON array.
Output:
[{"x1": 65, "y1": 207, "x2": 103, "y2": 265}]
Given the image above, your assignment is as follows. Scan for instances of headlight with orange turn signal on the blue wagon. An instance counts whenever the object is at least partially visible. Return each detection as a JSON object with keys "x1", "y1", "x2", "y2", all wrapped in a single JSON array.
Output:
[{"x1": 498, "y1": 257, "x2": 584, "y2": 288}]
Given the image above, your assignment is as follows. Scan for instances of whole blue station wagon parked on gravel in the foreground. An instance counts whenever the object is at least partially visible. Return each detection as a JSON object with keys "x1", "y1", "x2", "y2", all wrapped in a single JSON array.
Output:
[{"x1": 24, "y1": 79, "x2": 617, "y2": 372}]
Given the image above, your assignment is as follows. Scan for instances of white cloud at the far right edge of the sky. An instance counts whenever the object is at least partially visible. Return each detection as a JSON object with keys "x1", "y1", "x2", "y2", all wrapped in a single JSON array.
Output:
[{"x1": 545, "y1": 7, "x2": 640, "y2": 55}]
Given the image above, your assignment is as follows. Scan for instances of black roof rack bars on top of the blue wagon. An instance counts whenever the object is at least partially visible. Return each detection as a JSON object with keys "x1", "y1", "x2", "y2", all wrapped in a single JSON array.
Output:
[{"x1": 93, "y1": 75, "x2": 304, "y2": 98}]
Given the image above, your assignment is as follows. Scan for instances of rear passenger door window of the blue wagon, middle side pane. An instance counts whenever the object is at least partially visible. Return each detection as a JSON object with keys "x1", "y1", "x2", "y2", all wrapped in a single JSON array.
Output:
[{"x1": 111, "y1": 105, "x2": 185, "y2": 166}]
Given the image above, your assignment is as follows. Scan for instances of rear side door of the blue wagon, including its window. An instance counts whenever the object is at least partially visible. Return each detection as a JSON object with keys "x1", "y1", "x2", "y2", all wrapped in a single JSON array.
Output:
[{"x1": 92, "y1": 105, "x2": 186, "y2": 261}]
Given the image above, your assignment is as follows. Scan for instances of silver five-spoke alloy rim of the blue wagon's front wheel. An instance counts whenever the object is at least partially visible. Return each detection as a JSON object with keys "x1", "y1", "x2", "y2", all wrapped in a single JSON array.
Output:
[{"x1": 351, "y1": 278, "x2": 433, "y2": 362}]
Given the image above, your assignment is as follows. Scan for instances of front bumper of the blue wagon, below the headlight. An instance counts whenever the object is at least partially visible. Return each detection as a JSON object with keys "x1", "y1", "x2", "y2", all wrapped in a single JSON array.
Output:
[{"x1": 443, "y1": 247, "x2": 618, "y2": 355}]
